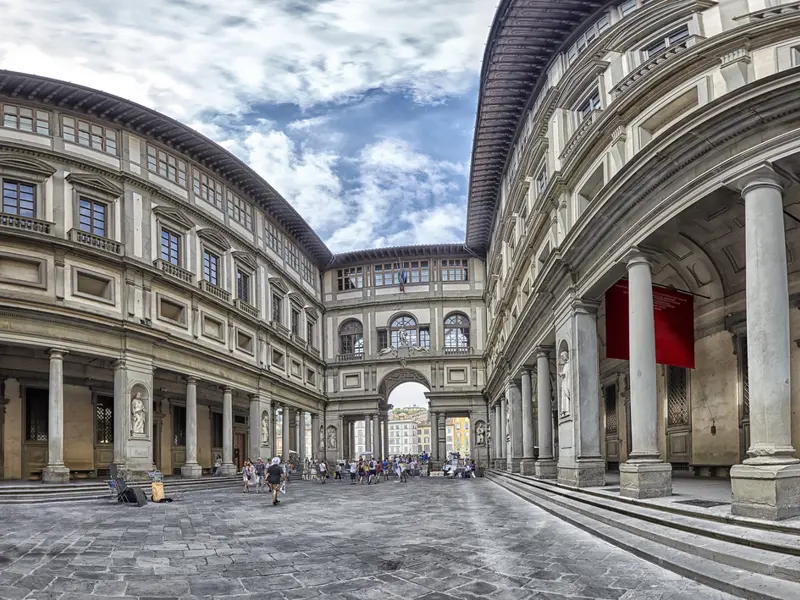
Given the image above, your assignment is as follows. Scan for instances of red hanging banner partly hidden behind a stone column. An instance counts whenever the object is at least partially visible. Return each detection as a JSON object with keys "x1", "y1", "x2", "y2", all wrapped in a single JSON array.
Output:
[{"x1": 606, "y1": 280, "x2": 694, "y2": 369}]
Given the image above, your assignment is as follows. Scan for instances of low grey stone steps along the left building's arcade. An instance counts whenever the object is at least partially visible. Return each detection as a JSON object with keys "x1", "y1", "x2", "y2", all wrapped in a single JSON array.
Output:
[{"x1": 0, "y1": 476, "x2": 242, "y2": 504}]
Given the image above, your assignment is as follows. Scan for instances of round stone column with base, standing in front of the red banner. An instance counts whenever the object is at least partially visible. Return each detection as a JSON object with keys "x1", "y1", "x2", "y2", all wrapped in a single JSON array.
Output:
[{"x1": 619, "y1": 250, "x2": 672, "y2": 498}]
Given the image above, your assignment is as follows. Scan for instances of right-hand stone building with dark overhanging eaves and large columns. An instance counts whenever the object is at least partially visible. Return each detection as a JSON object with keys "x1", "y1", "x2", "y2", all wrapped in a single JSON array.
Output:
[{"x1": 476, "y1": 0, "x2": 800, "y2": 518}]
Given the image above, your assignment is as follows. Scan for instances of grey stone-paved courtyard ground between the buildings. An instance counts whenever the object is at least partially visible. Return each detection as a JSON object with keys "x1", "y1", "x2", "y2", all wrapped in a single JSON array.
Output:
[{"x1": 0, "y1": 478, "x2": 731, "y2": 600}]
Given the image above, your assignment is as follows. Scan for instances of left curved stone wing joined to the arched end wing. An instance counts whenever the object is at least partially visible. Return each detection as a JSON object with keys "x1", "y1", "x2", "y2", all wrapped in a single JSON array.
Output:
[{"x1": 0, "y1": 71, "x2": 488, "y2": 482}]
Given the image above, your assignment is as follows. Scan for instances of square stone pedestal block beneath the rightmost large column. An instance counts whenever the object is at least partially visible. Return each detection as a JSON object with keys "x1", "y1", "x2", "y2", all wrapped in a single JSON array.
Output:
[{"x1": 731, "y1": 463, "x2": 800, "y2": 521}]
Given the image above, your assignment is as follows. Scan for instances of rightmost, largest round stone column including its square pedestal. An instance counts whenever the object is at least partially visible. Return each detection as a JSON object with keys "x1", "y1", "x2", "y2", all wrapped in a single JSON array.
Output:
[{"x1": 731, "y1": 168, "x2": 800, "y2": 520}]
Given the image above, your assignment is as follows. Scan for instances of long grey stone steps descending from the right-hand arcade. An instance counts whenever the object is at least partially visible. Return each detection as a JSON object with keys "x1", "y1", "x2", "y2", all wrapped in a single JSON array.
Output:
[{"x1": 489, "y1": 473, "x2": 800, "y2": 600}]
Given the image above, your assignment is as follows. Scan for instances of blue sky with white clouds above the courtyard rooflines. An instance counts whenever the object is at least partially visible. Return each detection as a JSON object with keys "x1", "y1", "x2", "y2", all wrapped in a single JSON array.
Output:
[{"x1": 0, "y1": 0, "x2": 496, "y2": 252}]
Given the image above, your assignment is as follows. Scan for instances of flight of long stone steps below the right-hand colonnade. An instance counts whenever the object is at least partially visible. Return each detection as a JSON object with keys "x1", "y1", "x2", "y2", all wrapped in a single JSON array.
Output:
[{"x1": 487, "y1": 471, "x2": 800, "y2": 600}]
